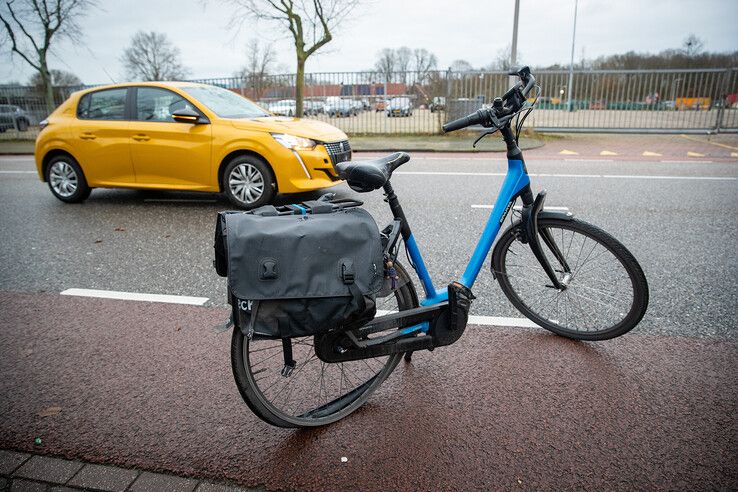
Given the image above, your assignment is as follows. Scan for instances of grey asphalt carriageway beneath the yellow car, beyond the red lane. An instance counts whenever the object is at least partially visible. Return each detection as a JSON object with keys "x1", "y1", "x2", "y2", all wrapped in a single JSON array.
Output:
[{"x1": 0, "y1": 154, "x2": 738, "y2": 340}]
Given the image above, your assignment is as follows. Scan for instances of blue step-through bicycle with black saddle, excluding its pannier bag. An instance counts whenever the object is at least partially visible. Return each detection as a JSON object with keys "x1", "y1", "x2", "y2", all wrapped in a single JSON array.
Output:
[{"x1": 231, "y1": 67, "x2": 648, "y2": 427}]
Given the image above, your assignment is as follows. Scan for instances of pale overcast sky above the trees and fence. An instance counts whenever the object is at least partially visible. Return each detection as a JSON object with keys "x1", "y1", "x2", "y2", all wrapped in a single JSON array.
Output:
[{"x1": 0, "y1": 0, "x2": 738, "y2": 84}]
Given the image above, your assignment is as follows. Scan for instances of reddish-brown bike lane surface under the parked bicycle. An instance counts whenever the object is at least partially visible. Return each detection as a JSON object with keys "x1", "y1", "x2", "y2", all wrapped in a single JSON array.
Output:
[{"x1": 0, "y1": 292, "x2": 738, "y2": 490}]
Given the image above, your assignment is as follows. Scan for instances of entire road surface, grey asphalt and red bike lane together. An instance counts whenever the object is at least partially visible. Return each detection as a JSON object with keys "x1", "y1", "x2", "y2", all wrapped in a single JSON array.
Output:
[{"x1": 0, "y1": 155, "x2": 738, "y2": 491}]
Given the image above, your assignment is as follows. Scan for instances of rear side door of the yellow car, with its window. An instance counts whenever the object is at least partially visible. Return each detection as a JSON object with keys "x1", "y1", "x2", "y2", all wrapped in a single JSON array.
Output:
[{"x1": 70, "y1": 87, "x2": 136, "y2": 186}]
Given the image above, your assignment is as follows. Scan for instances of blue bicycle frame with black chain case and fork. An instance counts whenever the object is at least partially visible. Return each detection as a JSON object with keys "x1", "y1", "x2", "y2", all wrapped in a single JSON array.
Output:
[{"x1": 315, "y1": 125, "x2": 569, "y2": 362}]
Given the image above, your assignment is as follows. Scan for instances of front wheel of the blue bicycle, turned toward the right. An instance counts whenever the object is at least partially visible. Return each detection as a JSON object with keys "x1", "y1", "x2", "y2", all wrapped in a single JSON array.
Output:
[{"x1": 492, "y1": 218, "x2": 648, "y2": 340}]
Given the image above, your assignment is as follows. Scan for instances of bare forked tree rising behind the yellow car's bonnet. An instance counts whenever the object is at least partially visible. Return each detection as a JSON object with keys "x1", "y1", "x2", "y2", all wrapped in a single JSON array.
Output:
[{"x1": 227, "y1": 0, "x2": 358, "y2": 117}]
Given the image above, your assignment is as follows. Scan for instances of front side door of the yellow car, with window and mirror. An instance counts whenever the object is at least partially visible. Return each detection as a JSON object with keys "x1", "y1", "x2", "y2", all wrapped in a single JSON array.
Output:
[{"x1": 129, "y1": 87, "x2": 212, "y2": 190}]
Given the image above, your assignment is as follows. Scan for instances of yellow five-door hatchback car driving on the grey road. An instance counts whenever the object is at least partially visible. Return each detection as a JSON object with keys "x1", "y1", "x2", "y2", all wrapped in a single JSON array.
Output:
[{"x1": 35, "y1": 82, "x2": 351, "y2": 209}]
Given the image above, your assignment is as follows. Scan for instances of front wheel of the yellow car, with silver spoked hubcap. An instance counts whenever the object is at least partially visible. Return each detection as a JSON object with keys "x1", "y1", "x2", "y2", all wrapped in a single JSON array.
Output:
[{"x1": 221, "y1": 155, "x2": 276, "y2": 210}]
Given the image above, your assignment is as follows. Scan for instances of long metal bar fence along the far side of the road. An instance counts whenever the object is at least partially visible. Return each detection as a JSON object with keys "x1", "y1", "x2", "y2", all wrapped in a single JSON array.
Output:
[{"x1": 0, "y1": 68, "x2": 738, "y2": 138}]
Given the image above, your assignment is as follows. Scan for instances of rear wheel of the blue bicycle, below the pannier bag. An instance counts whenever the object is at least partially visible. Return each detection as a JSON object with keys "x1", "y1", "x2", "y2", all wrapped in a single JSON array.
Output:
[{"x1": 231, "y1": 263, "x2": 418, "y2": 427}]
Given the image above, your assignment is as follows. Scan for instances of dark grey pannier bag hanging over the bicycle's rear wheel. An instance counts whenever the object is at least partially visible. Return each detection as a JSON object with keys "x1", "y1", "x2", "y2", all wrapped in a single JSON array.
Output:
[{"x1": 214, "y1": 202, "x2": 384, "y2": 339}]
